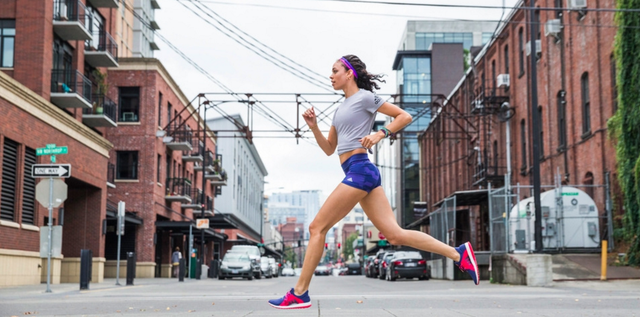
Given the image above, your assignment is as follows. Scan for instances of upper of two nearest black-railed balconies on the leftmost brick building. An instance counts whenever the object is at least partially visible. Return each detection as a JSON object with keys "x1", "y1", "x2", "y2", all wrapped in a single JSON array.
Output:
[{"x1": 53, "y1": 0, "x2": 91, "y2": 41}]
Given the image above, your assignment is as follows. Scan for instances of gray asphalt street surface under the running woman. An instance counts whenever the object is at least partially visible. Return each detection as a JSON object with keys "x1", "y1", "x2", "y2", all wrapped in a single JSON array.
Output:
[{"x1": 0, "y1": 276, "x2": 640, "y2": 317}]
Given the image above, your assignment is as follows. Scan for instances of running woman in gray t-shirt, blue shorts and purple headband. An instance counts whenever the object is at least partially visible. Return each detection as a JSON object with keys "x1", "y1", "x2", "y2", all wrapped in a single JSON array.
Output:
[{"x1": 269, "y1": 55, "x2": 479, "y2": 309}]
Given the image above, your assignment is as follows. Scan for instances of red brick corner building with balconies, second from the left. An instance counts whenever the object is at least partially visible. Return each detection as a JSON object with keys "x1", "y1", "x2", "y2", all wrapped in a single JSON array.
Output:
[{"x1": 106, "y1": 58, "x2": 226, "y2": 277}]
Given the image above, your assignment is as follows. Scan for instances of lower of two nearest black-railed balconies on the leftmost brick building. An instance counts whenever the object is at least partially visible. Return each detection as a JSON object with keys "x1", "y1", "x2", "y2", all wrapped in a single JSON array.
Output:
[{"x1": 51, "y1": 69, "x2": 92, "y2": 108}]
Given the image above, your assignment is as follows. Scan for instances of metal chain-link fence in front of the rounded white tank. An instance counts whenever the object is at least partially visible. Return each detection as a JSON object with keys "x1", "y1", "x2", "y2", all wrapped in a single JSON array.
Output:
[{"x1": 488, "y1": 175, "x2": 614, "y2": 253}]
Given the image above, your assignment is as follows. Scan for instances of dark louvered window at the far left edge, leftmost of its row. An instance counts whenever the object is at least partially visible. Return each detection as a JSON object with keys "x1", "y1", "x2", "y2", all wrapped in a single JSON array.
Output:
[{"x1": 0, "y1": 138, "x2": 18, "y2": 221}]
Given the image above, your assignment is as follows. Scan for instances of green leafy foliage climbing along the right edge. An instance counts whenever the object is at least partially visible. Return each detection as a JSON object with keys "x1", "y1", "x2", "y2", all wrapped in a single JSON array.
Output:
[{"x1": 608, "y1": 0, "x2": 640, "y2": 266}]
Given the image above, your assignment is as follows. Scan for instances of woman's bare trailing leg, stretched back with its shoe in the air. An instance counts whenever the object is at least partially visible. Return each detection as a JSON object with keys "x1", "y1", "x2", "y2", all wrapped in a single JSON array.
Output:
[{"x1": 360, "y1": 187, "x2": 460, "y2": 262}]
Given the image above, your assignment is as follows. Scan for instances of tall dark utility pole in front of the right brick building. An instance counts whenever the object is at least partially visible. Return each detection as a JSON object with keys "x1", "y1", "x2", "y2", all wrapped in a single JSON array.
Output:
[{"x1": 529, "y1": 0, "x2": 542, "y2": 253}]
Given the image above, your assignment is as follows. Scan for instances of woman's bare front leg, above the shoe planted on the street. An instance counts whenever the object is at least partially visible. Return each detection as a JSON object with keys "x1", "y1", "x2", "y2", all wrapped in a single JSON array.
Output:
[{"x1": 294, "y1": 184, "x2": 367, "y2": 295}]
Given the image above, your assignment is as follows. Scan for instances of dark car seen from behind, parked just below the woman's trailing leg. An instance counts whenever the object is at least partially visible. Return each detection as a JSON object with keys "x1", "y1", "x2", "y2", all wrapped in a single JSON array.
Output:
[{"x1": 385, "y1": 251, "x2": 431, "y2": 281}]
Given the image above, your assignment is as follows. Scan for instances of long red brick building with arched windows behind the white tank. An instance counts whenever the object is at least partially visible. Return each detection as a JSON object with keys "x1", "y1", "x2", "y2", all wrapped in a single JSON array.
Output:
[{"x1": 413, "y1": 0, "x2": 620, "y2": 250}]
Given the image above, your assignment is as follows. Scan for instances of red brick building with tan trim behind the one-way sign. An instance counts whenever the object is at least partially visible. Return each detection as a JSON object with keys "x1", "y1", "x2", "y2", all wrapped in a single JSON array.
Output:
[{"x1": 0, "y1": 0, "x2": 118, "y2": 285}]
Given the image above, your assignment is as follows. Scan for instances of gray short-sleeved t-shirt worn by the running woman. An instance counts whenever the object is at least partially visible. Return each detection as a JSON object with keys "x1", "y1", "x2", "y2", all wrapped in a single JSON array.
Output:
[{"x1": 332, "y1": 89, "x2": 384, "y2": 155}]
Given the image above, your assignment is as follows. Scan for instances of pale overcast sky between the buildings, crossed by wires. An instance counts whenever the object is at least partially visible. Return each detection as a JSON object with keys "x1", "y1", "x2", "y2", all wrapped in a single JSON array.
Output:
[{"x1": 155, "y1": 0, "x2": 517, "y2": 196}]
